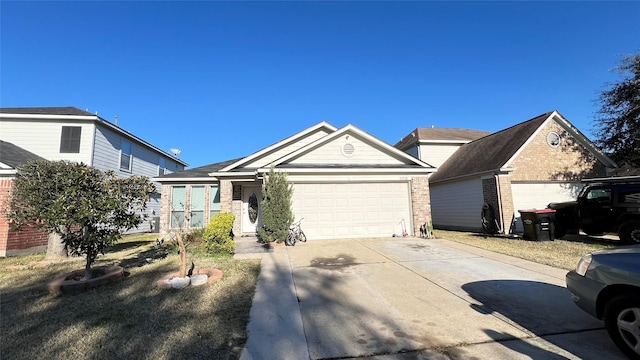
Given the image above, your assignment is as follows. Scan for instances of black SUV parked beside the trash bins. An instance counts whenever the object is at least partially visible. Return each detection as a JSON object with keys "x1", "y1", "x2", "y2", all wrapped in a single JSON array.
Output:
[{"x1": 547, "y1": 176, "x2": 640, "y2": 244}]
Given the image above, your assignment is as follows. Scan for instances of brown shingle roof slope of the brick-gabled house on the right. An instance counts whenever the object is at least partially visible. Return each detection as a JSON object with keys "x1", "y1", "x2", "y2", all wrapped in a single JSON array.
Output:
[{"x1": 429, "y1": 111, "x2": 553, "y2": 182}]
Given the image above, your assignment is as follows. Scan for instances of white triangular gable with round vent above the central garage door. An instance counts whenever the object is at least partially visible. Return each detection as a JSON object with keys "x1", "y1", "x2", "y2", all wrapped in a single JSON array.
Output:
[{"x1": 289, "y1": 135, "x2": 410, "y2": 165}]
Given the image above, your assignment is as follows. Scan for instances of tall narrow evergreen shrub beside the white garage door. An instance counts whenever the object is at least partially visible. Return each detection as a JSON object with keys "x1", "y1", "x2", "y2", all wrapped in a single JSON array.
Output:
[{"x1": 258, "y1": 166, "x2": 294, "y2": 242}]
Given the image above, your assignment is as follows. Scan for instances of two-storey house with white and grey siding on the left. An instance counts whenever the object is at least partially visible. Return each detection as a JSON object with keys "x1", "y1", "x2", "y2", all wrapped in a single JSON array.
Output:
[{"x1": 0, "y1": 107, "x2": 188, "y2": 253}]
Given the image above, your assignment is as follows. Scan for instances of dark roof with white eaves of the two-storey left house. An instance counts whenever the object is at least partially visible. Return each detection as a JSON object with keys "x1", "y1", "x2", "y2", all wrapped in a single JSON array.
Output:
[{"x1": 0, "y1": 106, "x2": 189, "y2": 166}]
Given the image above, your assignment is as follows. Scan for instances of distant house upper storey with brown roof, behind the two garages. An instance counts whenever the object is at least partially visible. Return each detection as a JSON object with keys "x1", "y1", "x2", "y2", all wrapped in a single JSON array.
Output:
[{"x1": 394, "y1": 127, "x2": 491, "y2": 167}]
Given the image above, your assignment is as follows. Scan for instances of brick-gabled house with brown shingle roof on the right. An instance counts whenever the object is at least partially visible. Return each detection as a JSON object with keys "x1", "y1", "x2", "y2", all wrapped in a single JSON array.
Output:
[{"x1": 400, "y1": 111, "x2": 617, "y2": 233}]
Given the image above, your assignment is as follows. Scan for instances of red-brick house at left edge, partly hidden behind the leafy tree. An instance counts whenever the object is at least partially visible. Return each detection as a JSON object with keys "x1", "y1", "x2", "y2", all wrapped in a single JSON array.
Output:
[{"x1": 0, "y1": 140, "x2": 48, "y2": 256}]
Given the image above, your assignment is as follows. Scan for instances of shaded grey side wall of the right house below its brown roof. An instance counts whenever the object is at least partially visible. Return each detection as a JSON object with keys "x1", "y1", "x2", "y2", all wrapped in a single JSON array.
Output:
[{"x1": 429, "y1": 178, "x2": 484, "y2": 231}]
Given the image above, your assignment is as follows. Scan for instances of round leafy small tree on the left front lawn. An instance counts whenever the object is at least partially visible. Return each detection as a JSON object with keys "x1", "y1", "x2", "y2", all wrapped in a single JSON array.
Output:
[{"x1": 7, "y1": 160, "x2": 156, "y2": 279}]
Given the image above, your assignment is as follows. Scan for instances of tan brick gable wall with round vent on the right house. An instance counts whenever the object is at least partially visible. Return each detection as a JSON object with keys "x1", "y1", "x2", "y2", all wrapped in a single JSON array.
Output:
[{"x1": 510, "y1": 121, "x2": 606, "y2": 181}]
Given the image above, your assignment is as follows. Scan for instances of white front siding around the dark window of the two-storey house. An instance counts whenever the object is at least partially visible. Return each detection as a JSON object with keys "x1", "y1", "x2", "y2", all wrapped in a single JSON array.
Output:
[{"x1": 0, "y1": 119, "x2": 95, "y2": 165}]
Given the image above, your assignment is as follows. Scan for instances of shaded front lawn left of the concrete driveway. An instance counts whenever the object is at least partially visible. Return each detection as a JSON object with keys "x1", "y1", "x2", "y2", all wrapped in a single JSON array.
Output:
[{"x1": 0, "y1": 234, "x2": 260, "y2": 360}]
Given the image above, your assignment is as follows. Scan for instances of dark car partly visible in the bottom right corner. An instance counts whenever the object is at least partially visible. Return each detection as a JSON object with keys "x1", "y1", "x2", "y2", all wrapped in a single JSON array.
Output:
[{"x1": 566, "y1": 245, "x2": 640, "y2": 359}]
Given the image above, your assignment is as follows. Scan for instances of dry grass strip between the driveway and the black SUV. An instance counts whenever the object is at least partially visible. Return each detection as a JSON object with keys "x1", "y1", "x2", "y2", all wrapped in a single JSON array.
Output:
[{"x1": 434, "y1": 230, "x2": 618, "y2": 270}]
